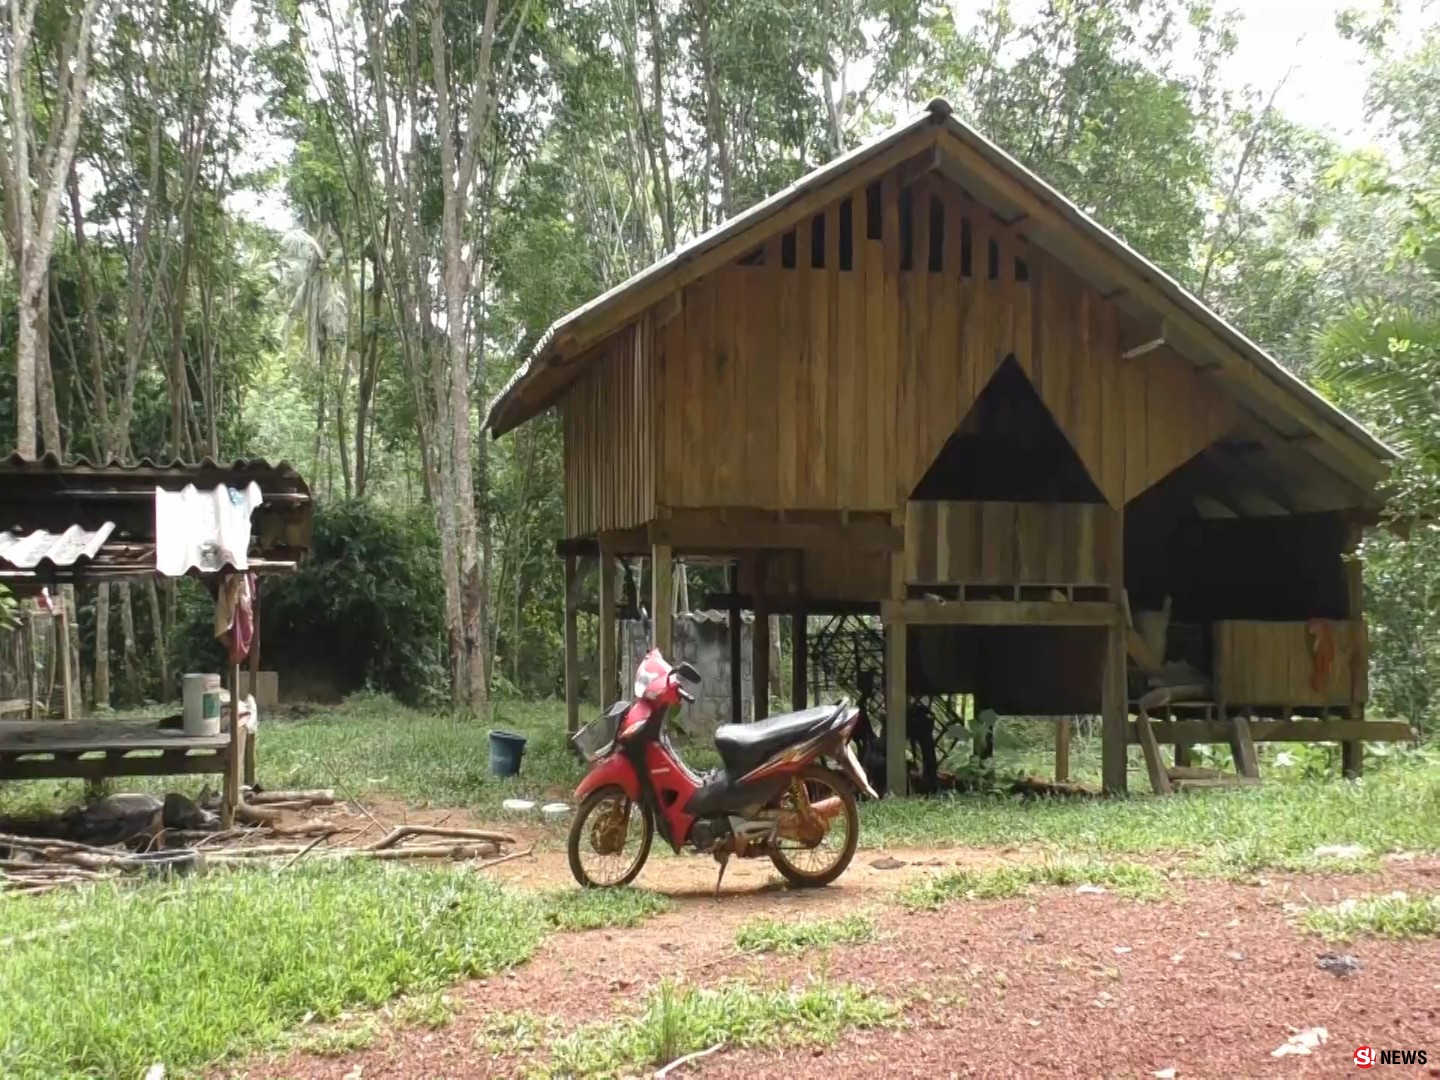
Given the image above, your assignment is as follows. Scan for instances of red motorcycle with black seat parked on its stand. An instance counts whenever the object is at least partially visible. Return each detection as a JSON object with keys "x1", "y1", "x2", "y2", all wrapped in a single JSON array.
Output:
[{"x1": 569, "y1": 649, "x2": 878, "y2": 893}]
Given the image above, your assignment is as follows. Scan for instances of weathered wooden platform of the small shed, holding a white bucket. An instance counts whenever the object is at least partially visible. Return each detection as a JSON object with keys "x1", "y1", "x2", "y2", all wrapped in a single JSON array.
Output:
[{"x1": 0, "y1": 720, "x2": 230, "y2": 780}]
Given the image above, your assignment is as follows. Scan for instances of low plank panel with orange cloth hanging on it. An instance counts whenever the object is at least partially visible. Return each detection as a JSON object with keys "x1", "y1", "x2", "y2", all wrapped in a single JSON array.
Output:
[{"x1": 1212, "y1": 619, "x2": 1369, "y2": 708}]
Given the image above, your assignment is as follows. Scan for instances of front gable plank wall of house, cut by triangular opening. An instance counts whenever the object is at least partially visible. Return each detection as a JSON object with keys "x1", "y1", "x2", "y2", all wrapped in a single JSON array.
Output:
[{"x1": 655, "y1": 164, "x2": 1237, "y2": 510}]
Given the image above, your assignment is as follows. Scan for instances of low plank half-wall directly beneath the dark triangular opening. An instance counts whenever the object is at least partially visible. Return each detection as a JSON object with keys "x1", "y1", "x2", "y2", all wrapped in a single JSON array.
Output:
[{"x1": 904, "y1": 503, "x2": 1116, "y2": 585}]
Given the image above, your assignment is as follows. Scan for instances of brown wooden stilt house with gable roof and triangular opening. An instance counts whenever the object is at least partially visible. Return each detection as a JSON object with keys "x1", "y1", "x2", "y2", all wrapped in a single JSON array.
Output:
[{"x1": 487, "y1": 101, "x2": 1403, "y2": 792}]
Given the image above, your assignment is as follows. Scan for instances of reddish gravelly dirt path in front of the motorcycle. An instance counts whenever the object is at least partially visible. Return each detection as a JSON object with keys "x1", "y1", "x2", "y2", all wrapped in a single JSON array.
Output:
[{"x1": 242, "y1": 850, "x2": 1440, "y2": 1080}]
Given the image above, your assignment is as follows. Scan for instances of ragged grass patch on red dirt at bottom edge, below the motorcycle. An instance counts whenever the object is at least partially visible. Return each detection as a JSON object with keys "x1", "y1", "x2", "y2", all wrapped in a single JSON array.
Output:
[{"x1": 552, "y1": 979, "x2": 900, "y2": 1076}]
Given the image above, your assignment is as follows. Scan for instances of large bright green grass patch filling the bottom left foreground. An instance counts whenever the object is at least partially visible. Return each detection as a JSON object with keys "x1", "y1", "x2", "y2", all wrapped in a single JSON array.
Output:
[{"x1": 0, "y1": 861, "x2": 670, "y2": 1077}]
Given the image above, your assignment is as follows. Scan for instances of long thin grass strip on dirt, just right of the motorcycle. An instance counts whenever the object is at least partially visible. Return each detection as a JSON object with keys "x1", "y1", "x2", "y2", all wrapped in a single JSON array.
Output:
[{"x1": 900, "y1": 860, "x2": 1169, "y2": 910}]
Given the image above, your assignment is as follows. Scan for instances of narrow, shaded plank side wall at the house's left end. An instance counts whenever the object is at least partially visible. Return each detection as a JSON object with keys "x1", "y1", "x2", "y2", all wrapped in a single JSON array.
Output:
[{"x1": 560, "y1": 317, "x2": 657, "y2": 537}]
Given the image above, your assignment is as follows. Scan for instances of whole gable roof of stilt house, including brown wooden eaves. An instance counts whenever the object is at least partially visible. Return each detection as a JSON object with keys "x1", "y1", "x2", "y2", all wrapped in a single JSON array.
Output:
[{"x1": 485, "y1": 98, "x2": 1395, "y2": 490}]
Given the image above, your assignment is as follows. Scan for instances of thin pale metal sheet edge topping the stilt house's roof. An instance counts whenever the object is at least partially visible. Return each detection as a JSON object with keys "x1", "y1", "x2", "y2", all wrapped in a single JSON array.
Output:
[{"x1": 485, "y1": 98, "x2": 1395, "y2": 472}]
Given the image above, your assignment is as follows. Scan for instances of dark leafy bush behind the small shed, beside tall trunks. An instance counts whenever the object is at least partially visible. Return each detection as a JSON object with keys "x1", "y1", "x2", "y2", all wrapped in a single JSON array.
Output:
[{"x1": 176, "y1": 501, "x2": 448, "y2": 704}]
